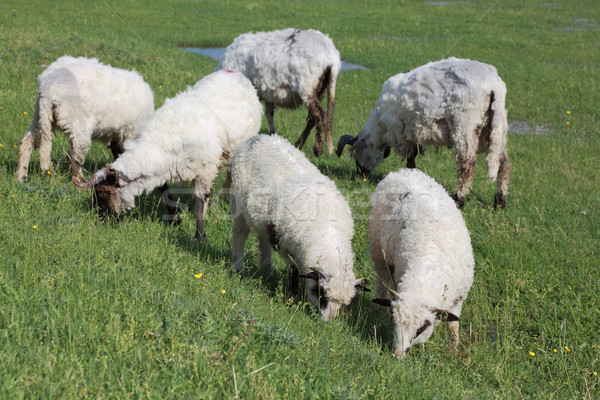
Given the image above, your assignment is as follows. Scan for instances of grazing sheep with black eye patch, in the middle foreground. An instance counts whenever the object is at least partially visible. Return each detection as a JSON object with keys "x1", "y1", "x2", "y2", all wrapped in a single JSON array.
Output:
[{"x1": 230, "y1": 135, "x2": 367, "y2": 321}]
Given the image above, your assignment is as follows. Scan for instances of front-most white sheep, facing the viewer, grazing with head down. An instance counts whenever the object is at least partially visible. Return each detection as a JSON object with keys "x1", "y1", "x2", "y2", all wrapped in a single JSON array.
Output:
[{"x1": 369, "y1": 169, "x2": 475, "y2": 358}]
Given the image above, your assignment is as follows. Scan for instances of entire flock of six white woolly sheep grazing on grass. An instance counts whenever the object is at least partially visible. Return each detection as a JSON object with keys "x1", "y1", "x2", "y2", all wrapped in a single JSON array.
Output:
[{"x1": 17, "y1": 28, "x2": 510, "y2": 358}]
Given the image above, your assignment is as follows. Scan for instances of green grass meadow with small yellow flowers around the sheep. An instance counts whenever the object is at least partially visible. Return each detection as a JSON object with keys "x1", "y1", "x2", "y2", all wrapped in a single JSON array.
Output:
[{"x1": 0, "y1": 0, "x2": 600, "y2": 399}]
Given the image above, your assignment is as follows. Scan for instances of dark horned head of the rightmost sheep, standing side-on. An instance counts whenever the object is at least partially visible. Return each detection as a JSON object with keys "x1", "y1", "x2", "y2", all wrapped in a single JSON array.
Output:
[{"x1": 335, "y1": 132, "x2": 391, "y2": 176}]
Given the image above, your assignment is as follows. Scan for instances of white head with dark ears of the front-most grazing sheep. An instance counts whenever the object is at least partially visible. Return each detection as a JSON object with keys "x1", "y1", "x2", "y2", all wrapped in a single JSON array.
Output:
[{"x1": 373, "y1": 290, "x2": 459, "y2": 359}]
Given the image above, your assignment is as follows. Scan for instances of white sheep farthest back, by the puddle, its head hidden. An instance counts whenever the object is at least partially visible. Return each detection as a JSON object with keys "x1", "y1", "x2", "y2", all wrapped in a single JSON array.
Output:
[{"x1": 217, "y1": 28, "x2": 342, "y2": 156}]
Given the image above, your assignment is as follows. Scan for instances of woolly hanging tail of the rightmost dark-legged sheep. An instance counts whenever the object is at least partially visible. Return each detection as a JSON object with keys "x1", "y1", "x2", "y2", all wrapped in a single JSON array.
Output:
[{"x1": 482, "y1": 91, "x2": 508, "y2": 182}]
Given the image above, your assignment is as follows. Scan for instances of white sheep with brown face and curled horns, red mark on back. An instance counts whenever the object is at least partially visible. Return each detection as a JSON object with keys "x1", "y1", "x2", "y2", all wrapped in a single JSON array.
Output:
[{"x1": 77, "y1": 71, "x2": 262, "y2": 240}]
